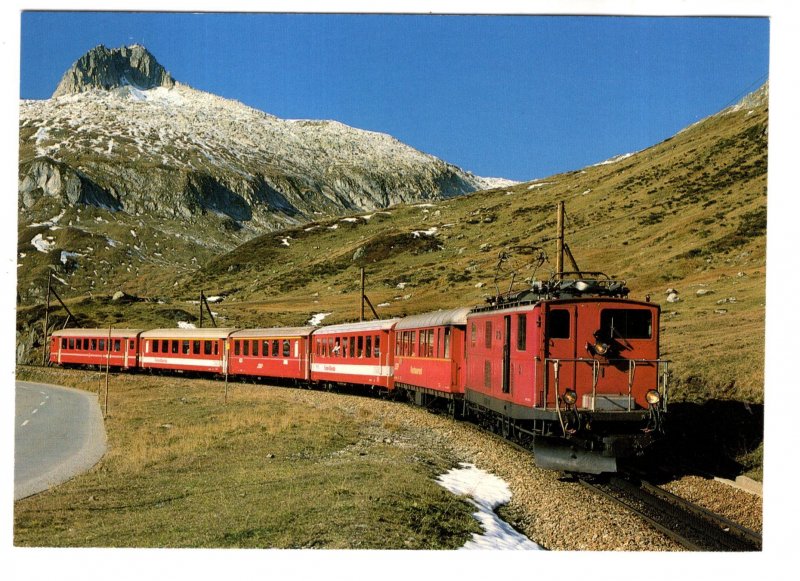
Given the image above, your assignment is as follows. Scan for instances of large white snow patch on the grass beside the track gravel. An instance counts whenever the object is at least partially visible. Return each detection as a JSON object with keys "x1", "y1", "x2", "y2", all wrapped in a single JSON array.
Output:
[{"x1": 436, "y1": 462, "x2": 541, "y2": 550}]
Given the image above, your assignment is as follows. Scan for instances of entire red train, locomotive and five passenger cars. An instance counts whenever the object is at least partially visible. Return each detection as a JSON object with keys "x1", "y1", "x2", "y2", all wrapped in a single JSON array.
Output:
[{"x1": 49, "y1": 272, "x2": 669, "y2": 474}]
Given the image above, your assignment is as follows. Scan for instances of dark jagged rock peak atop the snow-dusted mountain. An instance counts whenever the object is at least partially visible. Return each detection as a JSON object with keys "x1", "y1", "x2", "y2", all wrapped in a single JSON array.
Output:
[{"x1": 53, "y1": 44, "x2": 175, "y2": 98}]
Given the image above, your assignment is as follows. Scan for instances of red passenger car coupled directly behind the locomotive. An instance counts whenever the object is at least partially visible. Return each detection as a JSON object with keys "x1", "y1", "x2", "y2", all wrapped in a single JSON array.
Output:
[{"x1": 394, "y1": 308, "x2": 470, "y2": 405}]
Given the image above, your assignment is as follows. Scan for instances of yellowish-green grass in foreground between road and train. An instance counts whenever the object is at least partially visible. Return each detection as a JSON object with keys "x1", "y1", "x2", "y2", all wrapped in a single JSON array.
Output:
[{"x1": 14, "y1": 370, "x2": 479, "y2": 549}]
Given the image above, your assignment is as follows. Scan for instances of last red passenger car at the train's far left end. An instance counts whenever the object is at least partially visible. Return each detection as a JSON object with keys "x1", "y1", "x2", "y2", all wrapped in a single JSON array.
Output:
[{"x1": 50, "y1": 329, "x2": 142, "y2": 369}]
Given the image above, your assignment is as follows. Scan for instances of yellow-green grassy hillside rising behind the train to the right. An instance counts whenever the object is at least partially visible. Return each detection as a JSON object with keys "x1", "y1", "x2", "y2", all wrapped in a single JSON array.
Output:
[{"x1": 20, "y1": 90, "x2": 768, "y2": 403}]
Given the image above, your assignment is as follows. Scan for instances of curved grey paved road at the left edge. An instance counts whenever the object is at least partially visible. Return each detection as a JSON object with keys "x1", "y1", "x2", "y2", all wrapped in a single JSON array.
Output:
[{"x1": 14, "y1": 381, "x2": 106, "y2": 500}]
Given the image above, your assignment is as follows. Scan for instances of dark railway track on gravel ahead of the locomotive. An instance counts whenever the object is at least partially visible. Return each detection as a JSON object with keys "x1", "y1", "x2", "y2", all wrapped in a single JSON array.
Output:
[{"x1": 579, "y1": 476, "x2": 761, "y2": 552}]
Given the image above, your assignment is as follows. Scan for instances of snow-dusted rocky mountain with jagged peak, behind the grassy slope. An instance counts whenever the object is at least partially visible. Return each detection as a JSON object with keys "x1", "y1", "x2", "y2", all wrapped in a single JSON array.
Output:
[{"x1": 19, "y1": 46, "x2": 512, "y2": 235}]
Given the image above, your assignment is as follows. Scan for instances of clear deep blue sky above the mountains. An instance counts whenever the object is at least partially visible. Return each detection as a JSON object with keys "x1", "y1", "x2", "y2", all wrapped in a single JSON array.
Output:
[{"x1": 20, "y1": 12, "x2": 770, "y2": 180}]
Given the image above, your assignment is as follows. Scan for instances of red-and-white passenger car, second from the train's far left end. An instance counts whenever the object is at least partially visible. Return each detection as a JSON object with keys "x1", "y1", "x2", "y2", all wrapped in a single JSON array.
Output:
[{"x1": 139, "y1": 328, "x2": 235, "y2": 373}]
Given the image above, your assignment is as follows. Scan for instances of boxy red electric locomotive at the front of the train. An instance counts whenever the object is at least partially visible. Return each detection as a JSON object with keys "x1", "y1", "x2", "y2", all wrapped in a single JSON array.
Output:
[{"x1": 465, "y1": 279, "x2": 667, "y2": 472}]
